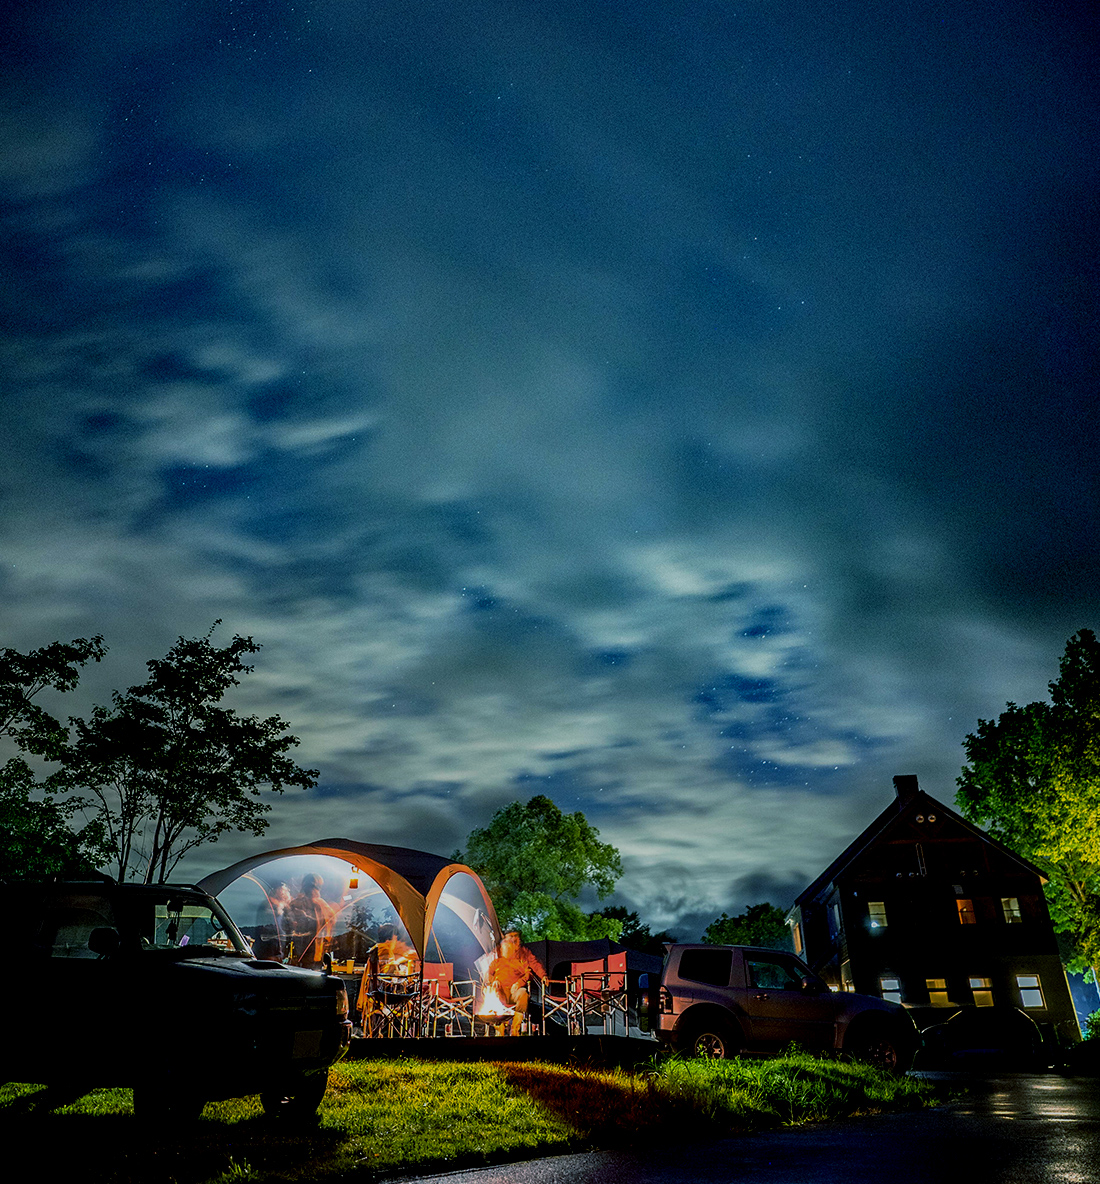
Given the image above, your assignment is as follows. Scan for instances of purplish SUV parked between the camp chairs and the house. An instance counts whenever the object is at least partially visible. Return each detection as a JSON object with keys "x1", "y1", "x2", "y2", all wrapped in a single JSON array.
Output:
[{"x1": 649, "y1": 945, "x2": 920, "y2": 1073}]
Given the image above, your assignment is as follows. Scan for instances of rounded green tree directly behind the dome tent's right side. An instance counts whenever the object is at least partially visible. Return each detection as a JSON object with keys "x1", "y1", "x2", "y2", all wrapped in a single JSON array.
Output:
[{"x1": 457, "y1": 794, "x2": 623, "y2": 941}]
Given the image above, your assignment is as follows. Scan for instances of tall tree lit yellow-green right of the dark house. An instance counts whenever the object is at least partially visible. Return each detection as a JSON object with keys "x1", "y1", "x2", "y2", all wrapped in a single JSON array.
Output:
[{"x1": 956, "y1": 629, "x2": 1100, "y2": 974}]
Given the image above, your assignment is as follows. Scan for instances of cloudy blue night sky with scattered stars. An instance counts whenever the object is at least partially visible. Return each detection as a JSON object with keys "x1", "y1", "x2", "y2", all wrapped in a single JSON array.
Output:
[{"x1": 0, "y1": 0, "x2": 1100, "y2": 937}]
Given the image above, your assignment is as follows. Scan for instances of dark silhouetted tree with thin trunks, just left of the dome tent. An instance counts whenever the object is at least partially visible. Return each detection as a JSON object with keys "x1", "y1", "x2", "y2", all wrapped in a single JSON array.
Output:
[{"x1": 58, "y1": 622, "x2": 317, "y2": 882}]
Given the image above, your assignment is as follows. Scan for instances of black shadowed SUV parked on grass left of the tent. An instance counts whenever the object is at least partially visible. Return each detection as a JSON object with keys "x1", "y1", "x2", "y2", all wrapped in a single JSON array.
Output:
[{"x1": 0, "y1": 879, "x2": 352, "y2": 1117}]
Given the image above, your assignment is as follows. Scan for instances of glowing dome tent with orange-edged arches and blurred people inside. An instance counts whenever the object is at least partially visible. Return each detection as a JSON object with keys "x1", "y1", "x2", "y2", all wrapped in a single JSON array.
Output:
[{"x1": 200, "y1": 838, "x2": 500, "y2": 979}]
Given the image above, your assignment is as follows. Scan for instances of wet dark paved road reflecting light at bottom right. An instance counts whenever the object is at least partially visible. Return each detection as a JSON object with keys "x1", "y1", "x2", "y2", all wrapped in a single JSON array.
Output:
[{"x1": 395, "y1": 1074, "x2": 1100, "y2": 1184}]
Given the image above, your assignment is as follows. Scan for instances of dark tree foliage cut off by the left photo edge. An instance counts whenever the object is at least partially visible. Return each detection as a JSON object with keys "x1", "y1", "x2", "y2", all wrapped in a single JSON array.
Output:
[{"x1": 0, "y1": 637, "x2": 105, "y2": 879}]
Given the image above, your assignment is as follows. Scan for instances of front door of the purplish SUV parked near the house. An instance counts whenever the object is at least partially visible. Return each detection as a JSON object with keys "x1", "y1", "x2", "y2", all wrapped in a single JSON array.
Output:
[{"x1": 745, "y1": 950, "x2": 836, "y2": 1049}]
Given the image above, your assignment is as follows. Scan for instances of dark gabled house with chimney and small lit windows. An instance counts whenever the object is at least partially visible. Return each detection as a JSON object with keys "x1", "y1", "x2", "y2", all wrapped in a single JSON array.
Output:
[{"x1": 789, "y1": 777, "x2": 1080, "y2": 1041}]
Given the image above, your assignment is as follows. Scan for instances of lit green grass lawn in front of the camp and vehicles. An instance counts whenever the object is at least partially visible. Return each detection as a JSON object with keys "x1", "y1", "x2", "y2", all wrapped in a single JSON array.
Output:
[{"x1": 0, "y1": 1054, "x2": 934, "y2": 1184}]
